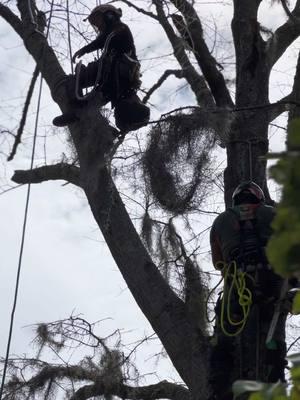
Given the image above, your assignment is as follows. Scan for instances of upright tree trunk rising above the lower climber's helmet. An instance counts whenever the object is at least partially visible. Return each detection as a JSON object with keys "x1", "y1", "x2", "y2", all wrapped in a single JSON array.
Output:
[{"x1": 224, "y1": 0, "x2": 270, "y2": 207}]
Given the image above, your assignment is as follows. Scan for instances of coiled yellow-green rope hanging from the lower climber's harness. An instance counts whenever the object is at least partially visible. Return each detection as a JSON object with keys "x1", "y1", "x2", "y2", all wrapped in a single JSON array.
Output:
[{"x1": 218, "y1": 261, "x2": 252, "y2": 337}]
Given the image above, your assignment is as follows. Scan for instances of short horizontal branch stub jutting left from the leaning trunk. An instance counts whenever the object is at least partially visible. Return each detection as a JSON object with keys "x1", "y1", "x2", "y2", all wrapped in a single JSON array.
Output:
[{"x1": 11, "y1": 163, "x2": 81, "y2": 186}]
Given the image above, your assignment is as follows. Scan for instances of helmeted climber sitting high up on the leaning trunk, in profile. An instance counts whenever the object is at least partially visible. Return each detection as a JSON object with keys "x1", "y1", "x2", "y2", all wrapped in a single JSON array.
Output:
[{"x1": 53, "y1": 4, "x2": 150, "y2": 132}]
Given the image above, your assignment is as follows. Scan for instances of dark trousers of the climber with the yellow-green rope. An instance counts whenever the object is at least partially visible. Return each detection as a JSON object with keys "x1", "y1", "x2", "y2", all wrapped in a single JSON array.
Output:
[{"x1": 210, "y1": 270, "x2": 287, "y2": 400}]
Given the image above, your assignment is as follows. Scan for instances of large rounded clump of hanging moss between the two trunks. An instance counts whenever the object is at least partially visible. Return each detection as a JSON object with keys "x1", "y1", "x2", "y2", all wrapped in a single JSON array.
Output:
[{"x1": 143, "y1": 111, "x2": 226, "y2": 215}]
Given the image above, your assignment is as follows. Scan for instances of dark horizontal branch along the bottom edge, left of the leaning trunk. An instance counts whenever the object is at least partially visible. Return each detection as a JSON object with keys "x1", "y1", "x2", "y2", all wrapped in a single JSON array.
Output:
[{"x1": 70, "y1": 381, "x2": 190, "y2": 400}]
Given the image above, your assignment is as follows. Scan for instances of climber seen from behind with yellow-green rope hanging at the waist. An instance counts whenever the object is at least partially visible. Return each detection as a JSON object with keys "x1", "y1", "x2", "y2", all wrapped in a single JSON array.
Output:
[{"x1": 210, "y1": 182, "x2": 288, "y2": 400}]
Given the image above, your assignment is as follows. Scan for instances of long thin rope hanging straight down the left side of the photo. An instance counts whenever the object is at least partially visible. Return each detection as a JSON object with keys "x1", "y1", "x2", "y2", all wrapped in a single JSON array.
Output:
[{"x1": 0, "y1": 0, "x2": 54, "y2": 400}]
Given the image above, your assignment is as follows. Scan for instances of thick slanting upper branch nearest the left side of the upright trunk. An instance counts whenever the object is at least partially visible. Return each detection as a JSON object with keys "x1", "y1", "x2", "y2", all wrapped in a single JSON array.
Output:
[{"x1": 171, "y1": 0, "x2": 233, "y2": 107}]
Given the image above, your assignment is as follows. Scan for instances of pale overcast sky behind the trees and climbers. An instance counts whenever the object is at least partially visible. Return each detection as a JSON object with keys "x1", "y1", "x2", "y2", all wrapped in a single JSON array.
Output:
[{"x1": 0, "y1": 1, "x2": 298, "y2": 394}]
